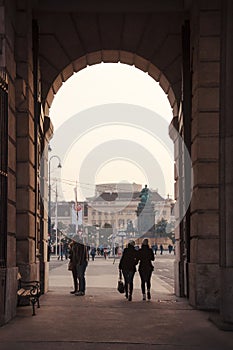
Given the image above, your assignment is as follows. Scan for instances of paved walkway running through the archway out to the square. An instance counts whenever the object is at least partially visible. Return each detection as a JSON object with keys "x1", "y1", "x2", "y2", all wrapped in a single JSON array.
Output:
[{"x1": 0, "y1": 259, "x2": 233, "y2": 350}]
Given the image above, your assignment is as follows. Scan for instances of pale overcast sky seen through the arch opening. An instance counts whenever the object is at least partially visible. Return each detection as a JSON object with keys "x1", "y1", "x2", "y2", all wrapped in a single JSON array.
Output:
[{"x1": 49, "y1": 63, "x2": 174, "y2": 201}]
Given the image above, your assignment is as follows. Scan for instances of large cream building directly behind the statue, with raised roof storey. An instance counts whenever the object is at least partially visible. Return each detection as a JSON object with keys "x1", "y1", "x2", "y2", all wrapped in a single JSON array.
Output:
[{"x1": 84, "y1": 183, "x2": 172, "y2": 232}]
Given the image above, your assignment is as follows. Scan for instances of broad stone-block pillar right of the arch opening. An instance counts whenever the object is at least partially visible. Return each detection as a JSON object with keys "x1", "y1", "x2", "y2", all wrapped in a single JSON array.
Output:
[{"x1": 189, "y1": 1, "x2": 221, "y2": 309}]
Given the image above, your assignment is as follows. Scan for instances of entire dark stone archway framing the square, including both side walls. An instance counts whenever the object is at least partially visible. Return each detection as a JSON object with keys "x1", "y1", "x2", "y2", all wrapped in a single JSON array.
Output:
[{"x1": 1, "y1": 0, "x2": 229, "y2": 322}]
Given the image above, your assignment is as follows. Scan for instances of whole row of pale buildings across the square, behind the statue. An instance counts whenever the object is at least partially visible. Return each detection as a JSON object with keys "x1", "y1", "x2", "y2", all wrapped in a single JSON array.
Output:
[{"x1": 48, "y1": 183, "x2": 175, "y2": 246}]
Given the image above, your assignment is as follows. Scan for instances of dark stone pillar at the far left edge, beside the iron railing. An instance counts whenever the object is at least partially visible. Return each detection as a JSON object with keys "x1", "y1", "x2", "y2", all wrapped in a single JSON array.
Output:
[{"x1": 0, "y1": 1, "x2": 18, "y2": 325}]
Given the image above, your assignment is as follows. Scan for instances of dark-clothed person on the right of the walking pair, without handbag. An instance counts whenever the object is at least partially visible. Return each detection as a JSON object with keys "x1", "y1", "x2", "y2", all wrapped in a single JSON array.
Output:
[{"x1": 138, "y1": 238, "x2": 155, "y2": 300}]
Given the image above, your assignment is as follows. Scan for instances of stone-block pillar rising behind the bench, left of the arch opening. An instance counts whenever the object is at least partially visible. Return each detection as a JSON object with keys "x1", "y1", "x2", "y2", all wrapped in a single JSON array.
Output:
[{"x1": 15, "y1": 1, "x2": 39, "y2": 279}]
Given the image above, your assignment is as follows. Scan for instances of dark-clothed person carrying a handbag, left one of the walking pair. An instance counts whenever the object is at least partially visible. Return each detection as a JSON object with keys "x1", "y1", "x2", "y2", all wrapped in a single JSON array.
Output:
[{"x1": 119, "y1": 241, "x2": 138, "y2": 301}]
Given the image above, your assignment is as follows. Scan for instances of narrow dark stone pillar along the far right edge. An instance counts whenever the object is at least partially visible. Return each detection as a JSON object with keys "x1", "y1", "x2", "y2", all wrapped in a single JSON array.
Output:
[{"x1": 220, "y1": 0, "x2": 233, "y2": 323}]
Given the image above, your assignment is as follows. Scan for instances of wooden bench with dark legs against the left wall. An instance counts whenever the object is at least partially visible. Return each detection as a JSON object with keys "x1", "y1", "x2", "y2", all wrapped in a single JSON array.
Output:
[{"x1": 17, "y1": 273, "x2": 41, "y2": 316}]
